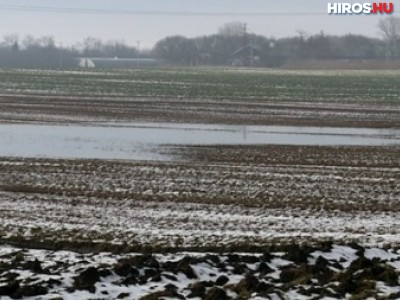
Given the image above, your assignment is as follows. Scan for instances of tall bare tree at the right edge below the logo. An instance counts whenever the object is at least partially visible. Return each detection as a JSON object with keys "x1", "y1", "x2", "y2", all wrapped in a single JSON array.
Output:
[{"x1": 378, "y1": 16, "x2": 400, "y2": 58}]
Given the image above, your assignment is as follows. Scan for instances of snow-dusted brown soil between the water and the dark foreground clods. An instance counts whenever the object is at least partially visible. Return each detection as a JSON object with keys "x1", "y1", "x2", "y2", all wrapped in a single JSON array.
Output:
[{"x1": 0, "y1": 146, "x2": 400, "y2": 248}]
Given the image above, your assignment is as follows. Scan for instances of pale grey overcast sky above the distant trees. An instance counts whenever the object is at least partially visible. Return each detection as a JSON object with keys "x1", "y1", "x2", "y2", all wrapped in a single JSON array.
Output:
[{"x1": 0, "y1": 0, "x2": 390, "y2": 47}]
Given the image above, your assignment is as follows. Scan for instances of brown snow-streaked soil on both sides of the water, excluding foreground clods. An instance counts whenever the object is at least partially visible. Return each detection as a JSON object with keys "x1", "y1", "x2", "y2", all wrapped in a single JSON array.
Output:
[{"x1": 0, "y1": 90, "x2": 400, "y2": 250}]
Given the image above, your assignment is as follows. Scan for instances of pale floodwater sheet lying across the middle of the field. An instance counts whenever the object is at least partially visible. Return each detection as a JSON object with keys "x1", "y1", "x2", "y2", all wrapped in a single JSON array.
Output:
[{"x1": 0, "y1": 123, "x2": 400, "y2": 160}]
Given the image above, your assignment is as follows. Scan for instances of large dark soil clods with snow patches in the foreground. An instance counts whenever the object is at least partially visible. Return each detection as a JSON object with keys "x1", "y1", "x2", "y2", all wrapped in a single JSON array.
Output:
[{"x1": 0, "y1": 243, "x2": 400, "y2": 300}]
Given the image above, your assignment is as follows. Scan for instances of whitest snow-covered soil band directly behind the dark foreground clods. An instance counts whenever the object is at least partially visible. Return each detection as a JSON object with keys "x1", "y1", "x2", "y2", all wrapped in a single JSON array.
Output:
[{"x1": 0, "y1": 193, "x2": 400, "y2": 249}]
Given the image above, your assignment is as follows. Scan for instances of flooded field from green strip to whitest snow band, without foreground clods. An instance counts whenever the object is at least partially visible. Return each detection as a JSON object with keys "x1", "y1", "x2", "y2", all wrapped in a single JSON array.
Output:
[{"x1": 0, "y1": 69, "x2": 400, "y2": 249}]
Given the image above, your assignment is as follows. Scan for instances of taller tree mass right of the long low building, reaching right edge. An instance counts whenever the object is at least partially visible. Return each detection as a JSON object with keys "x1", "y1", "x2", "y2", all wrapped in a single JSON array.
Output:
[{"x1": 153, "y1": 17, "x2": 400, "y2": 67}]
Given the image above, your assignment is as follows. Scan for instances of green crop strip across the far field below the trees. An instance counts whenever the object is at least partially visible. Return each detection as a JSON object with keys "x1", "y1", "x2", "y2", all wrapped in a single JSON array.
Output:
[{"x1": 0, "y1": 68, "x2": 400, "y2": 102}]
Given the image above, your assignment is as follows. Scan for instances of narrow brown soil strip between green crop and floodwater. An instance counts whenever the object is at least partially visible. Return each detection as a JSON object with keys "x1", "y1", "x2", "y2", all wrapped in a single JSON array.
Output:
[{"x1": 0, "y1": 95, "x2": 400, "y2": 128}]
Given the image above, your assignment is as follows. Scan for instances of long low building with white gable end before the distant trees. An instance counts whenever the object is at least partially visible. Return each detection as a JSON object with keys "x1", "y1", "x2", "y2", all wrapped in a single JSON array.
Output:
[{"x1": 78, "y1": 57, "x2": 162, "y2": 68}]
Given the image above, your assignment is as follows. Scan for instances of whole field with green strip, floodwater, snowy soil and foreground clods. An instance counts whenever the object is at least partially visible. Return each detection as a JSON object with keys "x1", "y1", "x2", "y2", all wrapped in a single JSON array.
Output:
[{"x1": 0, "y1": 69, "x2": 400, "y2": 300}]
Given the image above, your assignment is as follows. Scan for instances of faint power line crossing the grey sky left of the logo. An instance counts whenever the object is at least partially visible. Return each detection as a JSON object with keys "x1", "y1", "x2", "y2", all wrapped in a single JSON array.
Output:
[{"x1": 0, "y1": 4, "x2": 326, "y2": 17}]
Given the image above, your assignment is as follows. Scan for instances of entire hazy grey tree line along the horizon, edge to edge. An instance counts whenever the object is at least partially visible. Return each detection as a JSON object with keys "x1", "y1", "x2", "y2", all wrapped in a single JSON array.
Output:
[{"x1": 0, "y1": 17, "x2": 400, "y2": 68}]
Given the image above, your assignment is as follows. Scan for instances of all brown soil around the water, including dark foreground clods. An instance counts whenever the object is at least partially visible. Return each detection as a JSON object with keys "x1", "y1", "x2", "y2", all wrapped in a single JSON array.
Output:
[{"x1": 0, "y1": 72, "x2": 400, "y2": 300}]
